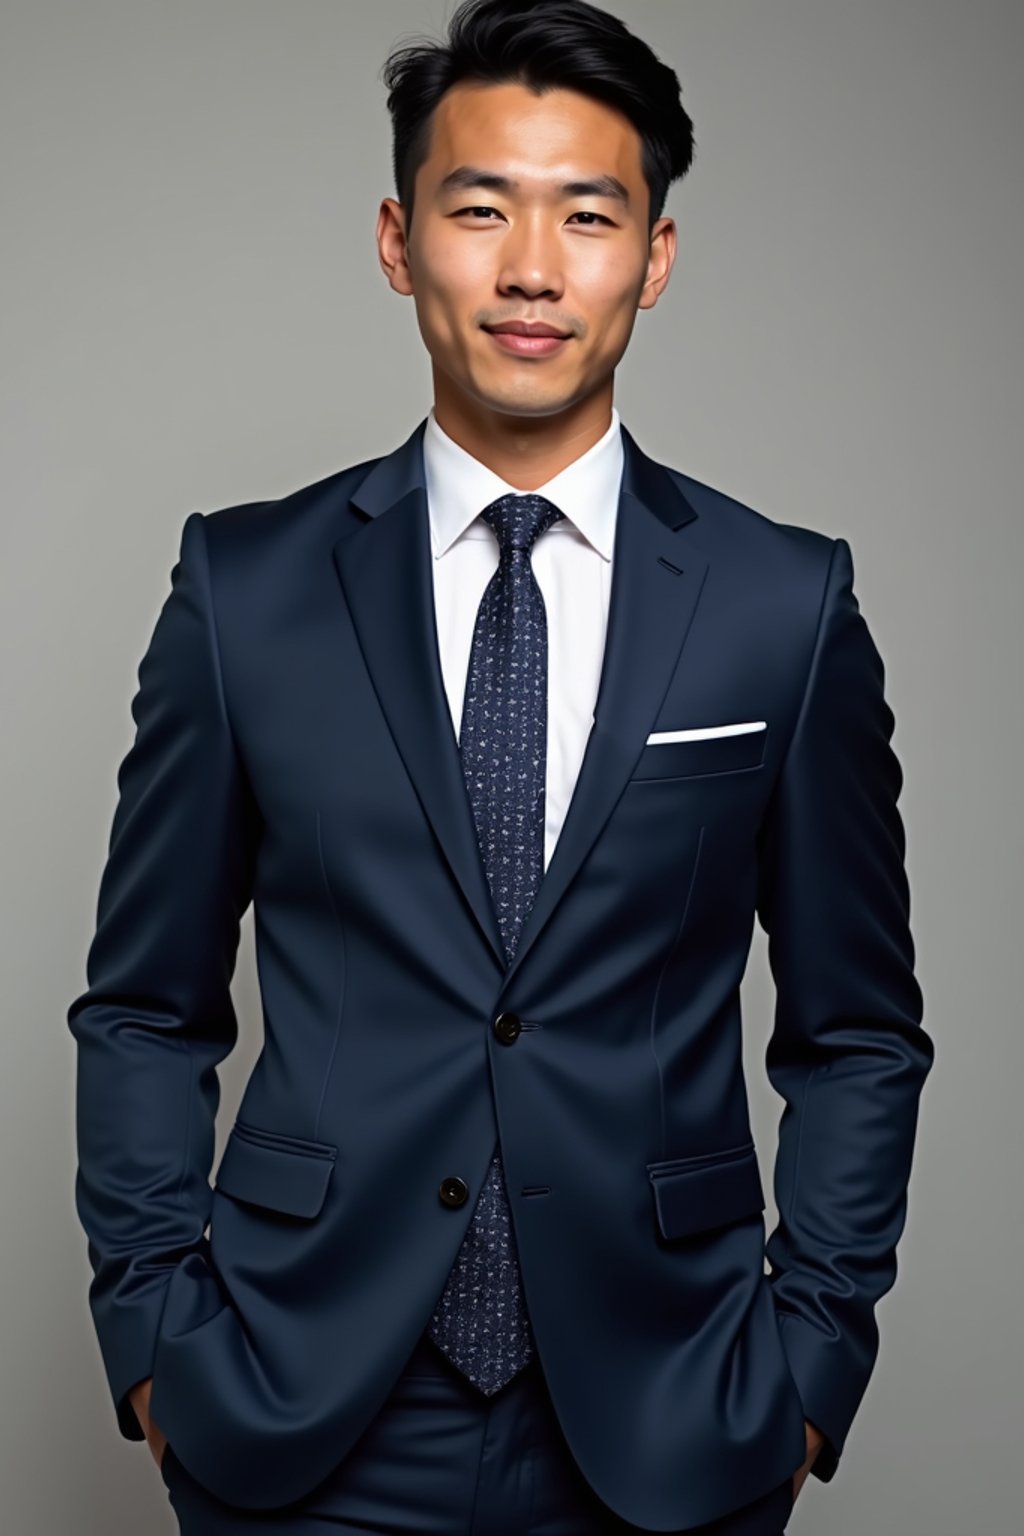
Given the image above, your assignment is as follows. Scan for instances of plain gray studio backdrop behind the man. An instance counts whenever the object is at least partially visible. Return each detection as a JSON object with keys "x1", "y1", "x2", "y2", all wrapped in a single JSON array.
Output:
[{"x1": 0, "y1": 0, "x2": 1024, "y2": 1536}]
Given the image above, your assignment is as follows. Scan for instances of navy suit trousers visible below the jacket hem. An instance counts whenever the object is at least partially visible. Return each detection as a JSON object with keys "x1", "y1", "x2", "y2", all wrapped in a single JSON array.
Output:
[{"x1": 160, "y1": 1335, "x2": 792, "y2": 1536}]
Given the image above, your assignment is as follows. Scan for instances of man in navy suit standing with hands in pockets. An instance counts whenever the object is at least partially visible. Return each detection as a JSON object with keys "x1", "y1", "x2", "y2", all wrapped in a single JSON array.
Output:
[{"x1": 69, "y1": 0, "x2": 932, "y2": 1536}]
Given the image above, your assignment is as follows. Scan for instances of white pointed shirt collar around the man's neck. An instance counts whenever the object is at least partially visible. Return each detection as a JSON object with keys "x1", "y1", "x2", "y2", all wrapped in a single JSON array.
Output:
[{"x1": 424, "y1": 406, "x2": 625, "y2": 561}]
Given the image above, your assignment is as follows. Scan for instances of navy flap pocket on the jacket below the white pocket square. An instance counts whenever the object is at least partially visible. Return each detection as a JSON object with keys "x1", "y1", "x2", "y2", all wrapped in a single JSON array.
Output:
[{"x1": 646, "y1": 1141, "x2": 765, "y2": 1238}]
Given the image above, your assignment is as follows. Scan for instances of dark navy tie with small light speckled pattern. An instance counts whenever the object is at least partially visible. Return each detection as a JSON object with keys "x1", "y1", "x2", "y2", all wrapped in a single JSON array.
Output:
[{"x1": 427, "y1": 495, "x2": 563, "y2": 1396}]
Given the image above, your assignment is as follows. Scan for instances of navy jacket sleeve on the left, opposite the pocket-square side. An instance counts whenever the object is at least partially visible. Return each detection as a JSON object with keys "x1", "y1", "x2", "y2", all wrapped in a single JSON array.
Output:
[{"x1": 68, "y1": 511, "x2": 258, "y2": 1439}]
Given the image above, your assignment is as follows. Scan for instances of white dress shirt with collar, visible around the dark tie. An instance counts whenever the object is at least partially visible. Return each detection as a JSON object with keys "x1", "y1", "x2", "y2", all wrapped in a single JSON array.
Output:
[{"x1": 424, "y1": 406, "x2": 623, "y2": 869}]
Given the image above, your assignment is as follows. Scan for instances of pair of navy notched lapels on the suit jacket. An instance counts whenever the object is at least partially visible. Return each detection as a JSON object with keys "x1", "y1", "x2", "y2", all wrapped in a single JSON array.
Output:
[{"x1": 333, "y1": 421, "x2": 708, "y2": 980}]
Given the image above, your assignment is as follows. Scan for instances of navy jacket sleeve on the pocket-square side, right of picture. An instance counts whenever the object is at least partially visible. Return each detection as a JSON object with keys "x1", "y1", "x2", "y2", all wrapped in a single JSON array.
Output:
[{"x1": 757, "y1": 539, "x2": 933, "y2": 1482}]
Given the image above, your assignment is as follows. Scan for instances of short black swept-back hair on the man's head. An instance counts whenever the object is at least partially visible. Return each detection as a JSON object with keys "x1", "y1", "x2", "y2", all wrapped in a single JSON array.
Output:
[{"x1": 381, "y1": 0, "x2": 694, "y2": 235}]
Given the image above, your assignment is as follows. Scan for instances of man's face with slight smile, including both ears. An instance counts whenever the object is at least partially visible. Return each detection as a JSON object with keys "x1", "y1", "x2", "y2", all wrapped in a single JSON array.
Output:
[{"x1": 378, "y1": 83, "x2": 676, "y2": 416}]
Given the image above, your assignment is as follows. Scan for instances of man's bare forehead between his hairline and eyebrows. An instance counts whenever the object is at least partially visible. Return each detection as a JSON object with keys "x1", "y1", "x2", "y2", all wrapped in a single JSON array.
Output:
[{"x1": 422, "y1": 81, "x2": 643, "y2": 190}]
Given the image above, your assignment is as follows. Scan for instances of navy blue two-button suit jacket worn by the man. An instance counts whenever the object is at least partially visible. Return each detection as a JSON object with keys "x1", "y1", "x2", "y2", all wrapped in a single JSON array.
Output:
[{"x1": 69, "y1": 422, "x2": 932, "y2": 1530}]
